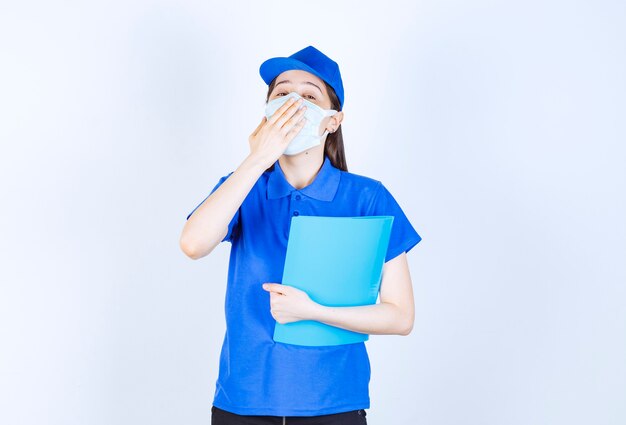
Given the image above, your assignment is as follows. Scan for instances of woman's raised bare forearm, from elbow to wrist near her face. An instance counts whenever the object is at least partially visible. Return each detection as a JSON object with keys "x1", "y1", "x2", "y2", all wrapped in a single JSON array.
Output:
[{"x1": 180, "y1": 156, "x2": 265, "y2": 258}]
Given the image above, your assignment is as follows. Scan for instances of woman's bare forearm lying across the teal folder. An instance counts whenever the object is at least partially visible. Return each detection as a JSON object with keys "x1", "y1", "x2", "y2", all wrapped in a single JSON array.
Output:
[{"x1": 311, "y1": 302, "x2": 413, "y2": 335}]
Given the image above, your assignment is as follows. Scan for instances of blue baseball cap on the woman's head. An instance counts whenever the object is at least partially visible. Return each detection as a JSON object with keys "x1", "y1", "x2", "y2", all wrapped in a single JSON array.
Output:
[{"x1": 259, "y1": 46, "x2": 343, "y2": 109}]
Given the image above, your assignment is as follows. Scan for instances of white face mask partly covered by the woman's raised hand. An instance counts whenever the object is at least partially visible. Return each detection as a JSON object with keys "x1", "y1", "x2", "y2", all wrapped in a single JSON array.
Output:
[{"x1": 265, "y1": 92, "x2": 337, "y2": 155}]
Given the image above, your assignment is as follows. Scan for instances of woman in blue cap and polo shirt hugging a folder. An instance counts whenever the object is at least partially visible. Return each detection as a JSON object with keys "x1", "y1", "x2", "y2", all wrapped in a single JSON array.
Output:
[{"x1": 180, "y1": 46, "x2": 421, "y2": 425}]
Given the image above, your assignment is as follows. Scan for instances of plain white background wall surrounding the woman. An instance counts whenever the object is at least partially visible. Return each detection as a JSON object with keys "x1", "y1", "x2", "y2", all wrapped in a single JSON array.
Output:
[{"x1": 0, "y1": 0, "x2": 626, "y2": 425}]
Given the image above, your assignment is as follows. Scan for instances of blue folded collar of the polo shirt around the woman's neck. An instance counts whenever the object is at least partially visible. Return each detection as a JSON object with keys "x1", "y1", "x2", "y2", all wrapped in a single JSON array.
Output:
[{"x1": 267, "y1": 155, "x2": 341, "y2": 201}]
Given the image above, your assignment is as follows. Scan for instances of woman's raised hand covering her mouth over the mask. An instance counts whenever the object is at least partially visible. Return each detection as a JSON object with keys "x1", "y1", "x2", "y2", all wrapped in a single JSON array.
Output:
[{"x1": 248, "y1": 98, "x2": 306, "y2": 169}]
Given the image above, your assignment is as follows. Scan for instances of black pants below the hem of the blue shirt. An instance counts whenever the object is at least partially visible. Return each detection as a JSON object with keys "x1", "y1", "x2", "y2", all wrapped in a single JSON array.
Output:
[{"x1": 211, "y1": 406, "x2": 367, "y2": 425}]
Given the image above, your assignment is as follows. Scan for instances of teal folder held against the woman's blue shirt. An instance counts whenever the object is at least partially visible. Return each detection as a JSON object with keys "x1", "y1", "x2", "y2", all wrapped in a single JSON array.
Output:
[{"x1": 274, "y1": 215, "x2": 394, "y2": 346}]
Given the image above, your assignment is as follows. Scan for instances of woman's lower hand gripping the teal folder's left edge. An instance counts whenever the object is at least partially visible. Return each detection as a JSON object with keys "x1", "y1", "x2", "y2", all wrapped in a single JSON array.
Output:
[{"x1": 263, "y1": 282, "x2": 319, "y2": 324}]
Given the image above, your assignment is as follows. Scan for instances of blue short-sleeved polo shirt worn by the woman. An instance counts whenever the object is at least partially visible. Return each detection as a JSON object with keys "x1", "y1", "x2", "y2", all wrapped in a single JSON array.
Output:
[{"x1": 187, "y1": 153, "x2": 422, "y2": 416}]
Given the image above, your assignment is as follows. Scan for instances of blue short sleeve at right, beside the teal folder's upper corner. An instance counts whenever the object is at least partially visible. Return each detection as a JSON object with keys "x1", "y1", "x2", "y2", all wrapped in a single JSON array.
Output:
[{"x1": 369, "y1": 182, "x2": 422, "y2": 262}]
